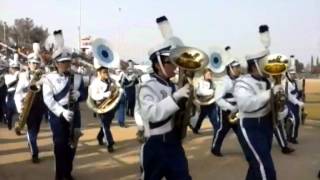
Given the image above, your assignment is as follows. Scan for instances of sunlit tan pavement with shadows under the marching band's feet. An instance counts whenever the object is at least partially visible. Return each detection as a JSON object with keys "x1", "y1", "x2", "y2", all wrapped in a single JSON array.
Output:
[{"x1": 0, "y1": 106, "x2": 320, "y2": 180}]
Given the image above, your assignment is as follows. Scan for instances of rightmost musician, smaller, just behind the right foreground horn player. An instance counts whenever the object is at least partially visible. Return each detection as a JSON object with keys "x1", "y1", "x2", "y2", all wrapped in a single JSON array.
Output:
[{"x1": 285, "y1": 64, "x2": 304, "y2": 144}]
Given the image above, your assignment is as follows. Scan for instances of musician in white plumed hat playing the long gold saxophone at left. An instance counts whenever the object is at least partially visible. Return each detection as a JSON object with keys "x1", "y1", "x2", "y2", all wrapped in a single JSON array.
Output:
[{"x1": 14, "y1": 43, "x2": 45, "y2": 163}]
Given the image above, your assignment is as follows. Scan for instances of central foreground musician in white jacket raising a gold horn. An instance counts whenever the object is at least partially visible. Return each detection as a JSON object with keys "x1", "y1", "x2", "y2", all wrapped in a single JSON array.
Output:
[{"x1": 136, "y1": 45, "x2": 191, "y2": 179}]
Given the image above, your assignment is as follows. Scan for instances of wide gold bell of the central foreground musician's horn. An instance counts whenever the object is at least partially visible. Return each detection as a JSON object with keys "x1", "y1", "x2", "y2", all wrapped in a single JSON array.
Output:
[{"x1": 169, "y1": 47, "x2": 209, "y2": 71}]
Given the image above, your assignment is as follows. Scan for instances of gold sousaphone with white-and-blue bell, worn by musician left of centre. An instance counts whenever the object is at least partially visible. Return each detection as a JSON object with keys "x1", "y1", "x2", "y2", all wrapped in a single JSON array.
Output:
[{"x1": 87, "y1": 38, "x2": 123, "y2": 114}]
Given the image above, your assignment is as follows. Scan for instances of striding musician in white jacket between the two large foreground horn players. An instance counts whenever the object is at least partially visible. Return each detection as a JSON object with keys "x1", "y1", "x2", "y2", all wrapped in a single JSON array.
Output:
[{"x1": 211, "y1": 54, "x2": 241, "y2": 156}]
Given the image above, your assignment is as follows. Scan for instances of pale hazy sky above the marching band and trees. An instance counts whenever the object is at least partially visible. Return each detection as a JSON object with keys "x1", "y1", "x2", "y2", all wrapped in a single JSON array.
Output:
[{"x1": 0, "y1": 0, "x2": 320, "y2": 62}]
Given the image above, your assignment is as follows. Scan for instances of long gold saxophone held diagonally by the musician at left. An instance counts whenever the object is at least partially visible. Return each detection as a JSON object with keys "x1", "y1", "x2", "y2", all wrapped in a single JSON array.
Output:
[{"x1": 15, "y1": 70, "x2": 43, "y2": 135}]
